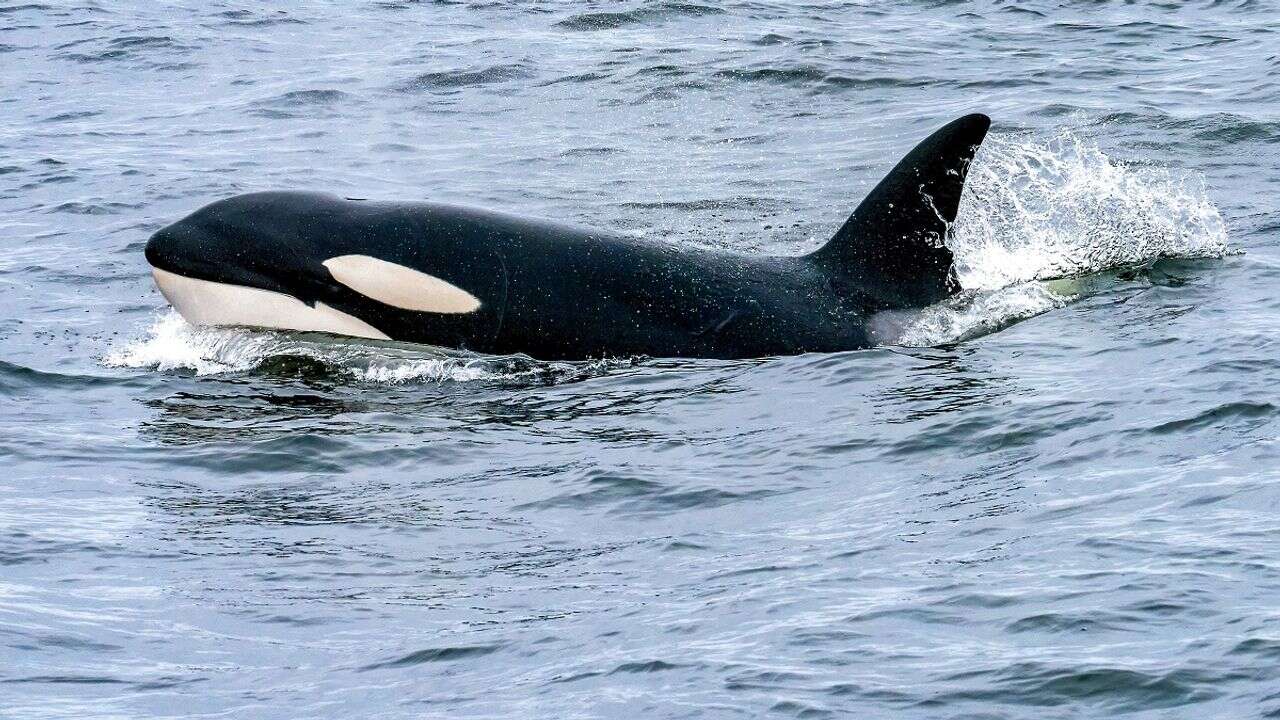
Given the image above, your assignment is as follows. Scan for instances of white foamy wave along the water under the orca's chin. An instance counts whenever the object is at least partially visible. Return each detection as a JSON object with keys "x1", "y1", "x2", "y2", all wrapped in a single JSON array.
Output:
[{"x1": 102, "y1": 310, "x2": 635, "y2": 384}]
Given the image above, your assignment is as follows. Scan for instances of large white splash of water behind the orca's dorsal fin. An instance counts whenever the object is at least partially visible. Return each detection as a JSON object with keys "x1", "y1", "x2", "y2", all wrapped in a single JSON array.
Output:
[{"x1": 893, "y1": 131, "x2": 1228, "y2": 346}]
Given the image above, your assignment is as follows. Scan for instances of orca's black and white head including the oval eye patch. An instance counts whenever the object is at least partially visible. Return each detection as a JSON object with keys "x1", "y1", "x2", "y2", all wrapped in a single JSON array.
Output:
[{"x1": 146, "y1": 192, "x2": 480, "y2": 340}]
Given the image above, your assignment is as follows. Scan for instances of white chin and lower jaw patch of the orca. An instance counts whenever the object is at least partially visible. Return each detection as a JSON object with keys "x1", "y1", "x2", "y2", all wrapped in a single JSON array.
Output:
[{"x1": 151, "y1": 268, "x2": 390, "y2": 340}]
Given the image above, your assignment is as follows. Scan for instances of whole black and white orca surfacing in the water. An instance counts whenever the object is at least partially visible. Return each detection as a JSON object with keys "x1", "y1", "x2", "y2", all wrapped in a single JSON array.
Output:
[{"x1": 146, "y1": 114, "x2": 991, "y2": 360}]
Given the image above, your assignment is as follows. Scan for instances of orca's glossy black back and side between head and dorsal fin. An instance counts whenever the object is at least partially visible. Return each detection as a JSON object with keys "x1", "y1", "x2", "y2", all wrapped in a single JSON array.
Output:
[{"x1": 340, "y1": 204, "x2": 873, "y2": 359}]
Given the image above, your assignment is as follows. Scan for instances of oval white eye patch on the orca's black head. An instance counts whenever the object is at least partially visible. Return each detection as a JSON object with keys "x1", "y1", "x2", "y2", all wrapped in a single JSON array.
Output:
[{"x1": 324, "y1": 255, "x2": 480, "y2": 314}]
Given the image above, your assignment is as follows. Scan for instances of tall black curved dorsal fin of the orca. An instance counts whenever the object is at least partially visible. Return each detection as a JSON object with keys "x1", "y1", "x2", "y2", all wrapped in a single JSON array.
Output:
[{"x1": 809, "y1": 114, "x2": 991, "y2": 307}]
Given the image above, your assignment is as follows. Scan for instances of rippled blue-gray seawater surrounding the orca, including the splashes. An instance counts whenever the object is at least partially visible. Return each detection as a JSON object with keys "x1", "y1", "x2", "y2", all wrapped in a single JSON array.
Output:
[{"x1": 0, "y1": 0, "x2": 1280, "y2": 719}]
